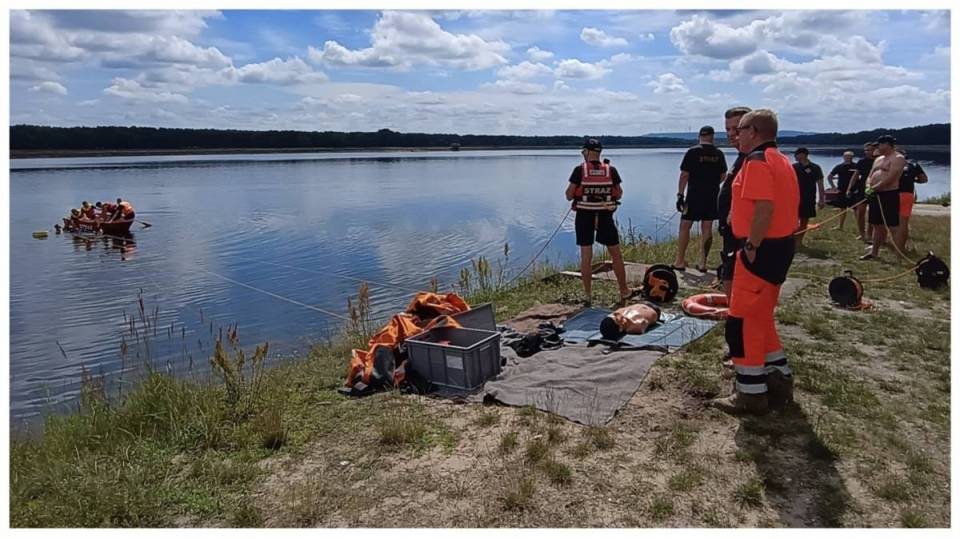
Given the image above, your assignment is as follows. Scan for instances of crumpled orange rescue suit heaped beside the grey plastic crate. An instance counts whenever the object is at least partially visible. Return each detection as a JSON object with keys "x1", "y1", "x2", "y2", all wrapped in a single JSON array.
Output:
[{"x1": 344, "y1": 292, "x2": 470, "y2": 387}]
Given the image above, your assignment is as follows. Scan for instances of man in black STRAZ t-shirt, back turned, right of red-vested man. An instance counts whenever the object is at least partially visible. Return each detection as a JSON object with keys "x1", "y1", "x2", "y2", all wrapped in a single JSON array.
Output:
[{"x1": 673, "y1": 125, "x2": 727, "y2": 272}]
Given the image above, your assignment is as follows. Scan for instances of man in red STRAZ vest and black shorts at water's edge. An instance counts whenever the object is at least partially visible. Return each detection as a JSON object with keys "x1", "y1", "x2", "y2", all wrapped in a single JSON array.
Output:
[{"x1": 566, "y1": 139, "x2": 630, "y2": 305}]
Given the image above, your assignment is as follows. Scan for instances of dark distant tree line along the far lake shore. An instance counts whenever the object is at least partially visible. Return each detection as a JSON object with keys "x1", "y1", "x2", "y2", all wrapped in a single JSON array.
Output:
[{"x1": 10, "y1": 124, "x2": 950, "y2": 151}]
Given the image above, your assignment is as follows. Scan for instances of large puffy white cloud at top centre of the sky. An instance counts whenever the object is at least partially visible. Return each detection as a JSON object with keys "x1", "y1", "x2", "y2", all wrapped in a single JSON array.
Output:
[{"x1": 309, "y1": 11, "x2": 510, "y2": 71}]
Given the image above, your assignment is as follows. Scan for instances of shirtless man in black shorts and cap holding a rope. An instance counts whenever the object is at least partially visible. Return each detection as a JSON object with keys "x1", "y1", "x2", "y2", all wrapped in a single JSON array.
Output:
[{"x1": 860, "y1": 135, "x2": 906, "y2": 260}]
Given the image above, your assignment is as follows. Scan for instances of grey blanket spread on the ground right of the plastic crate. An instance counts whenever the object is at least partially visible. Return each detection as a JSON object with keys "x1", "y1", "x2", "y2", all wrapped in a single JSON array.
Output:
[{"x1": 480, "y1": 344, "x2": 663, "y2": 426}]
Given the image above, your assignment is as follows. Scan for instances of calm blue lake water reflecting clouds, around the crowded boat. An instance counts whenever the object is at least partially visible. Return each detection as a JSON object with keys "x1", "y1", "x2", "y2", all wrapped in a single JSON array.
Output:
[{"x1": 10, "y1": 148, "x2": 950, "y2": 419}]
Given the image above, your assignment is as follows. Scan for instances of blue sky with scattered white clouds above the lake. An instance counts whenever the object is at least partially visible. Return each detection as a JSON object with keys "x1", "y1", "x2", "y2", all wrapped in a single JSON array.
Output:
[{"x1": 10, "y1": 10, "x2": 950, "y2": 135}]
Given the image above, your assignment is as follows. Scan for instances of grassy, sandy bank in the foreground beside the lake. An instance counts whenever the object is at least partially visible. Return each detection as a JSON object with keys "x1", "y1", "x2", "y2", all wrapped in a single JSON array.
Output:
[{"x1": 10, "y1": 212, "x2": 951, "y2": 527}]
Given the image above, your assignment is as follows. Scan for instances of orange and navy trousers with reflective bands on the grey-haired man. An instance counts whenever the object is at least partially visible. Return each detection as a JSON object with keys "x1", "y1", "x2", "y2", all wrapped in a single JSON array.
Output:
[{"x1": 726, "y1": 252, "x2": 792, "y2": 394}]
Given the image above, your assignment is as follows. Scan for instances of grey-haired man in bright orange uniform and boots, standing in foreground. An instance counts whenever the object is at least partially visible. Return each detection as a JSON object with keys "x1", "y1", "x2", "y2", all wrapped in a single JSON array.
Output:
[{"x1": 712, "y1": 109, "x2": 800, "y2": 415}]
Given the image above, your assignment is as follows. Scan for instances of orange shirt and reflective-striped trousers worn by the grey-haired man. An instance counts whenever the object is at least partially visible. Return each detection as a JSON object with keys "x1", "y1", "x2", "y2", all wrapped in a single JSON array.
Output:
[{"x1": 726, "y1": 142, "x2": 800, "y2": 394}]
